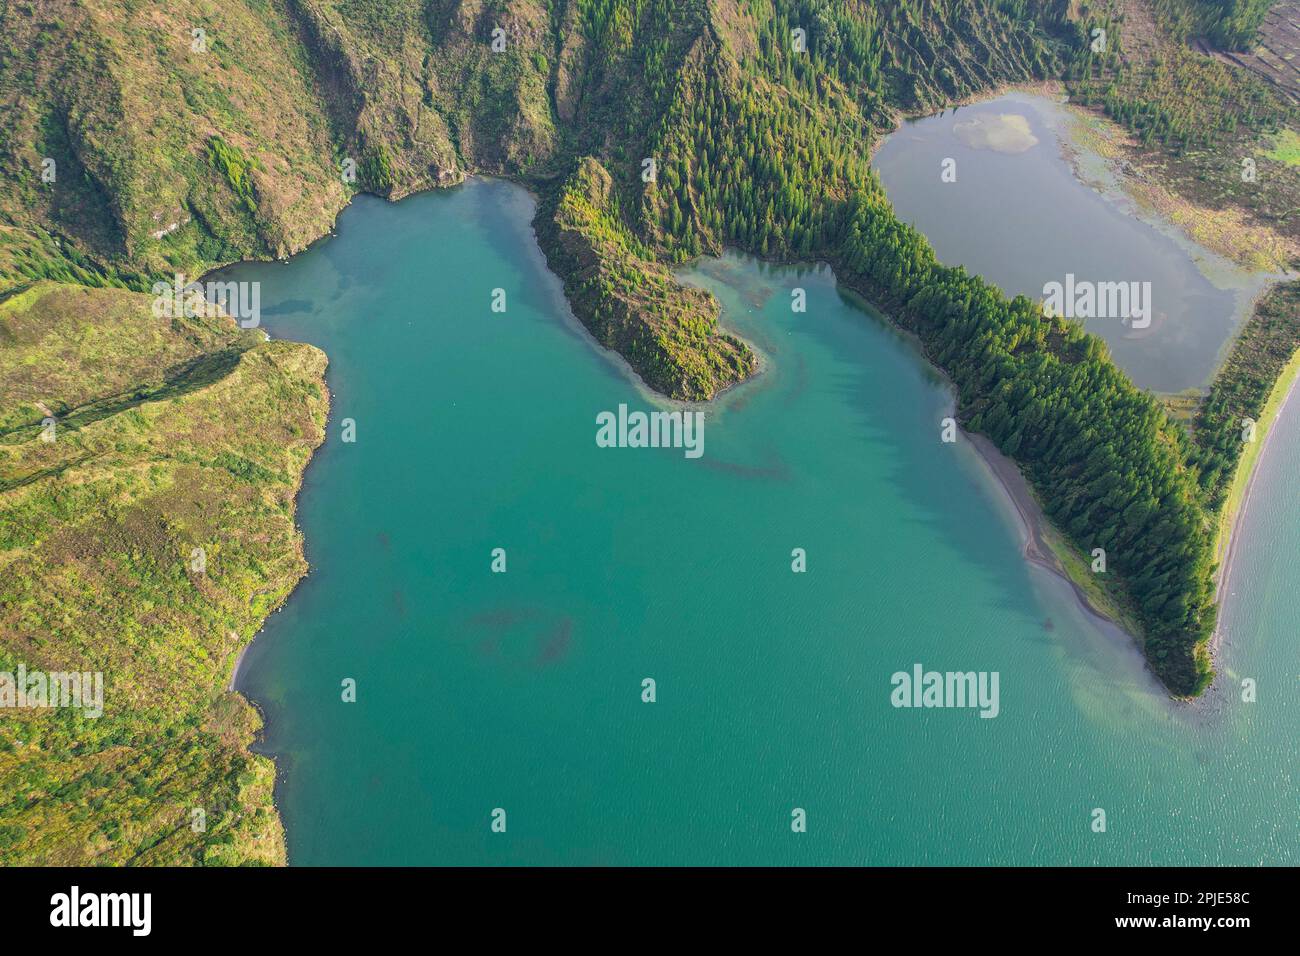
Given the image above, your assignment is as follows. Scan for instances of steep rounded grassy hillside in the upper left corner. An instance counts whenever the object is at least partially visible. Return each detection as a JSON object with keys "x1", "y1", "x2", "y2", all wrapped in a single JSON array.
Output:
[{"x1": 0, "y1": 0, "x2": 345, "y2": 271}]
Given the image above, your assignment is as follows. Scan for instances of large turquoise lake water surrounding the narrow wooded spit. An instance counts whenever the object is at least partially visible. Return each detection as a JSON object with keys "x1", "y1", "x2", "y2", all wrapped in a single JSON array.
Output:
[{"x1": 228, "y1": 182, "x2": 1300, "y2": 865}]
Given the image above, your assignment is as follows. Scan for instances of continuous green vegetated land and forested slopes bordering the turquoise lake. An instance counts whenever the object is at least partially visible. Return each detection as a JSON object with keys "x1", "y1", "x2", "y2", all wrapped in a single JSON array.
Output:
[{"x1": 0, "y1": 0, "x2": 1294, "y2": 862}]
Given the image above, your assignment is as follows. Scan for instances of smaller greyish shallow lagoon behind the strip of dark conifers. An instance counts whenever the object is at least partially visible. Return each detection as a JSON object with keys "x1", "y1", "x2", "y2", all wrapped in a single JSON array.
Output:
[{"x1": 875, "y1": 94, "x2": 1274, "y2": 393}]
